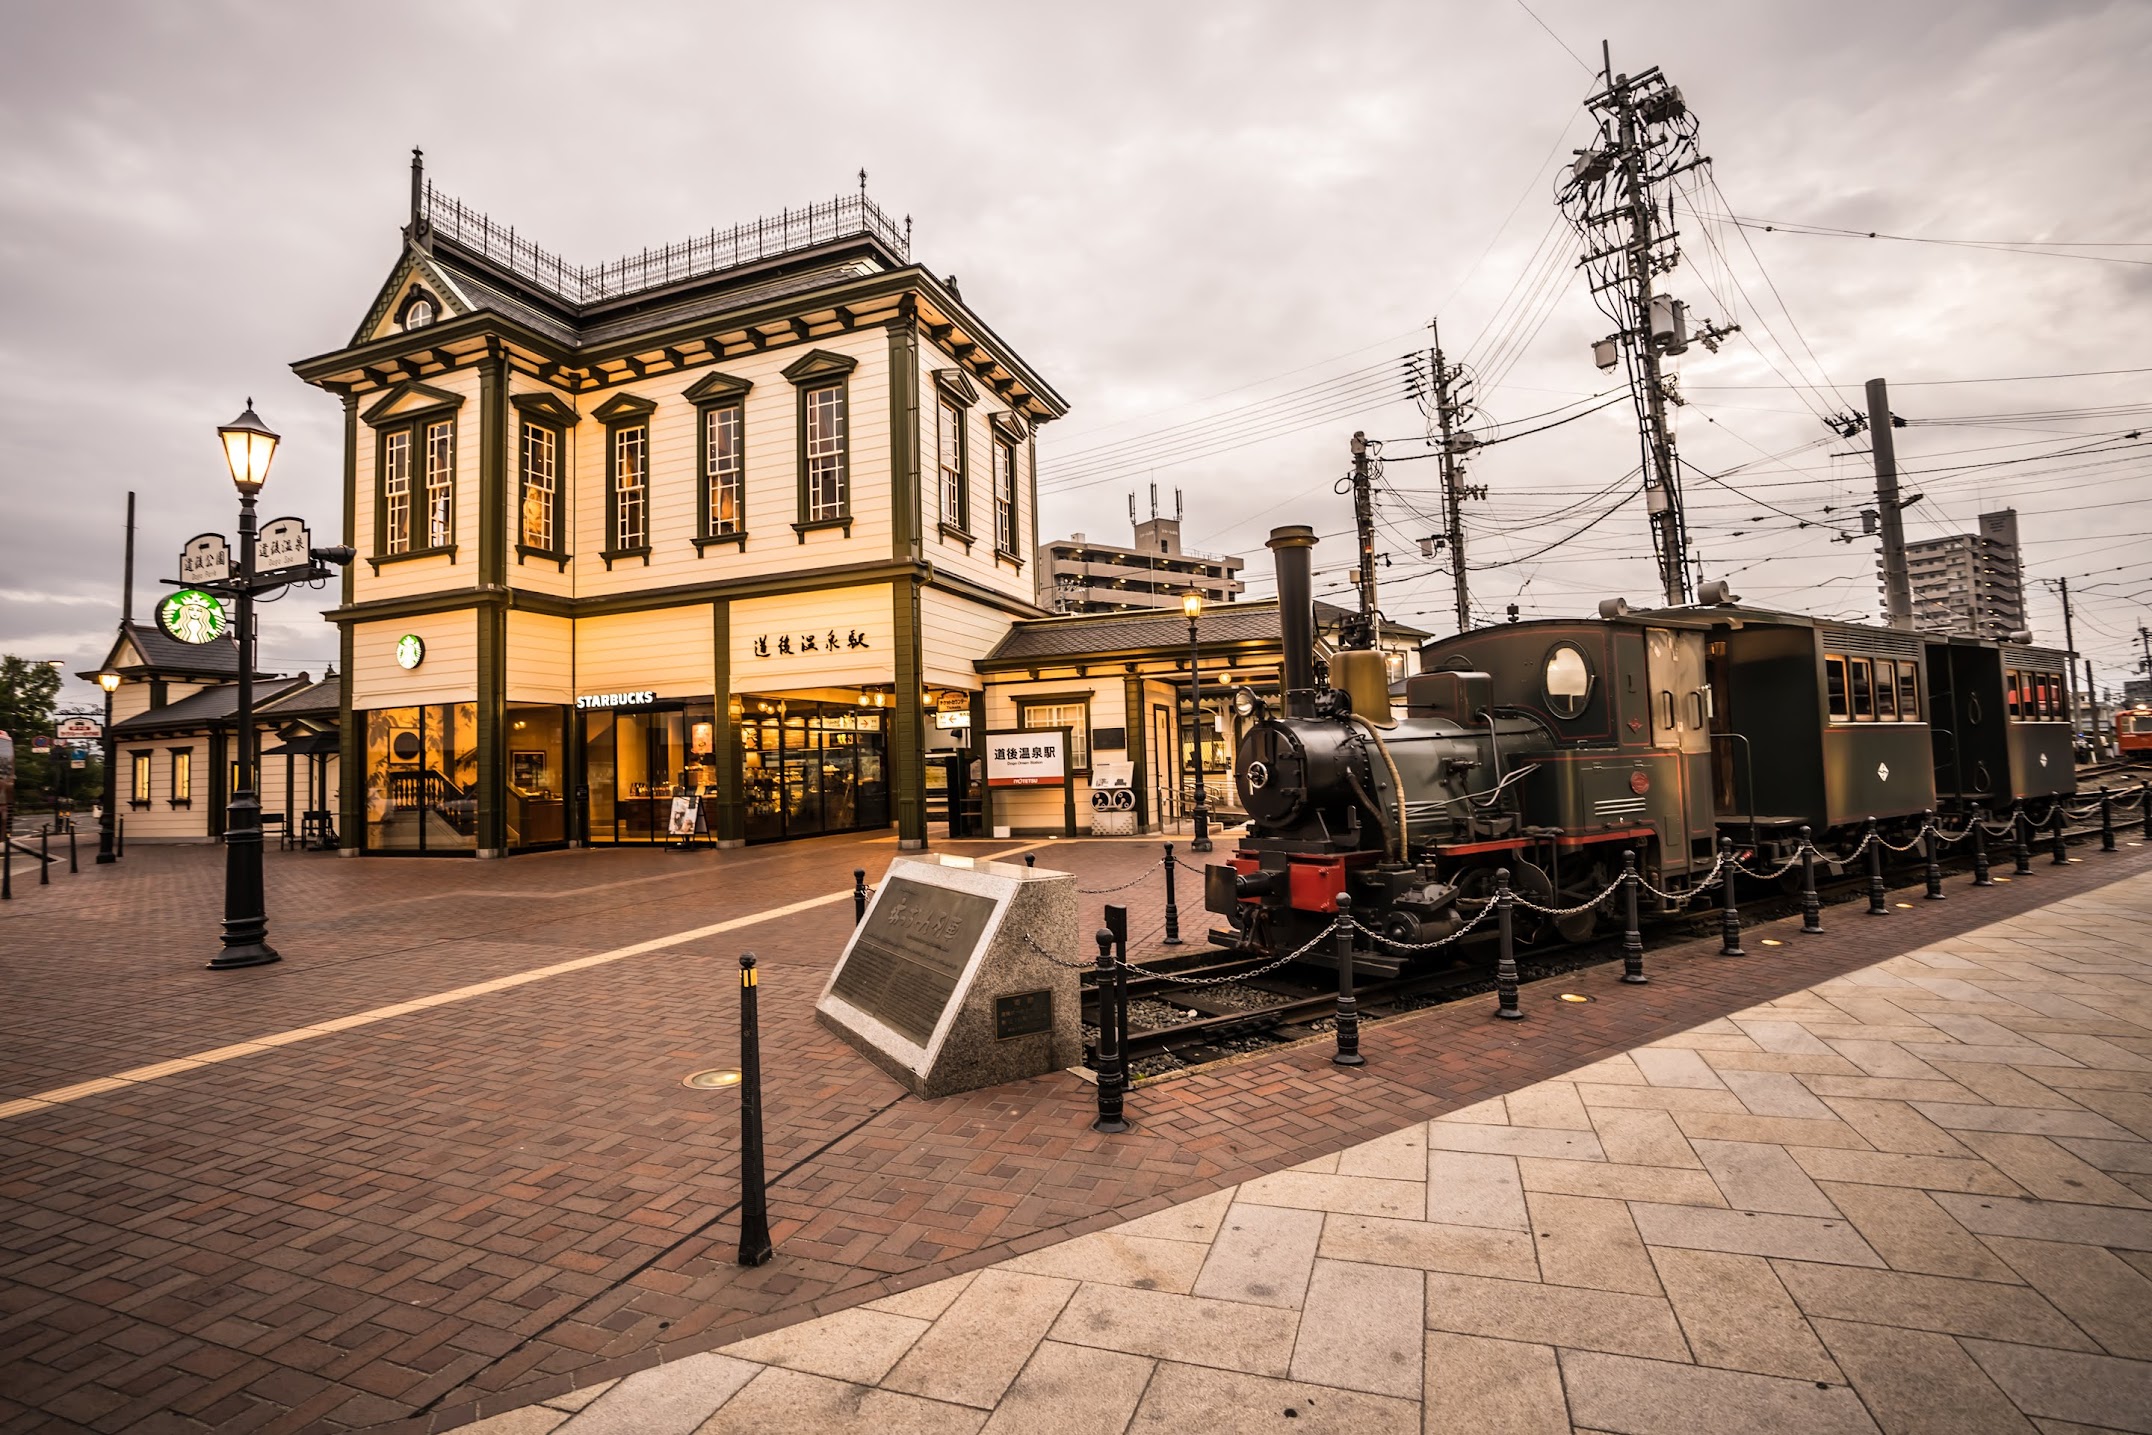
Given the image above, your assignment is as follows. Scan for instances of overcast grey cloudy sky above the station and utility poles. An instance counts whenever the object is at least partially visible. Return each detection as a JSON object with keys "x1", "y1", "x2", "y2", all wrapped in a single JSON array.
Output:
[{"x1": 0, "y1": 0, "x2": 2152, "y2": 697}]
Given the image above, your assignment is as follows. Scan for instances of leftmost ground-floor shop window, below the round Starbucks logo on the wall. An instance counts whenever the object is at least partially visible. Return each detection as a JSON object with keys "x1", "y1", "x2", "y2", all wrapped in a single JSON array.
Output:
[{"x1": 366, "y1": 704, "x2": 478, "y2": 852}]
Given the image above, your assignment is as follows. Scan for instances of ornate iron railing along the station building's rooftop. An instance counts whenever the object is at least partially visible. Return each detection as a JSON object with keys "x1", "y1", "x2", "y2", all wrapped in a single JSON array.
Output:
[{"x1": 424, "y1": 181, "x2": 912, "y2": 306}]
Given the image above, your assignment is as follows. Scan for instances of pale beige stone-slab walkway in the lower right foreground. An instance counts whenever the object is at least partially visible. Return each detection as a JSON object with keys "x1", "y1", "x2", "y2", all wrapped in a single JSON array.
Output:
[{"x1": 479, "y1": 873, "x2": 2152, "y2": 1435}]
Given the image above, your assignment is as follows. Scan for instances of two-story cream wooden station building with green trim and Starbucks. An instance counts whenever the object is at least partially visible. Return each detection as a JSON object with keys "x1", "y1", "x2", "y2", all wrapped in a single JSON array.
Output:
[{"x1": 295, "y1": 157, "x2": 1065, "y2": 856}]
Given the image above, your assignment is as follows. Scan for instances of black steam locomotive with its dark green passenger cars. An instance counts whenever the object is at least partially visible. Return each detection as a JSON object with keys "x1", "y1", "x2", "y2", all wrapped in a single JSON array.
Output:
[{"x1": 1203, "y1": 527, "x2": 2077, "y2": 972}]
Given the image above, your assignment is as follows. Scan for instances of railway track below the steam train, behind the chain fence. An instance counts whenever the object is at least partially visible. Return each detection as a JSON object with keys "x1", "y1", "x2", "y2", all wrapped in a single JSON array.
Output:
[{"x1": 1082, "y1": 822, "x2": 2137, "y2": 1080}]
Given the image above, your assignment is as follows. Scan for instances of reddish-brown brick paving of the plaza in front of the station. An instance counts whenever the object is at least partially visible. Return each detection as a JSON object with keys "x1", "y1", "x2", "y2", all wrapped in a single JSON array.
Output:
[{"x1": 0, "y1": 839, "x2": 2146, "y2": 1431}]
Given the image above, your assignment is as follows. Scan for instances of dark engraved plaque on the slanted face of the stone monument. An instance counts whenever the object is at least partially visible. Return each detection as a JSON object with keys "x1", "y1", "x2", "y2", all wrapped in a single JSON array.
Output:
[{"x1": 831, "y1": 878, "x2": 994, "y2": 1046}]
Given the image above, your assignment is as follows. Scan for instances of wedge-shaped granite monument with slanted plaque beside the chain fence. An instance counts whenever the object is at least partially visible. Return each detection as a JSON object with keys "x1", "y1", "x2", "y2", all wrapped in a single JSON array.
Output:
[{"x1": 816, "y1": 854, "x2": 1076, "y2": 1097}]
